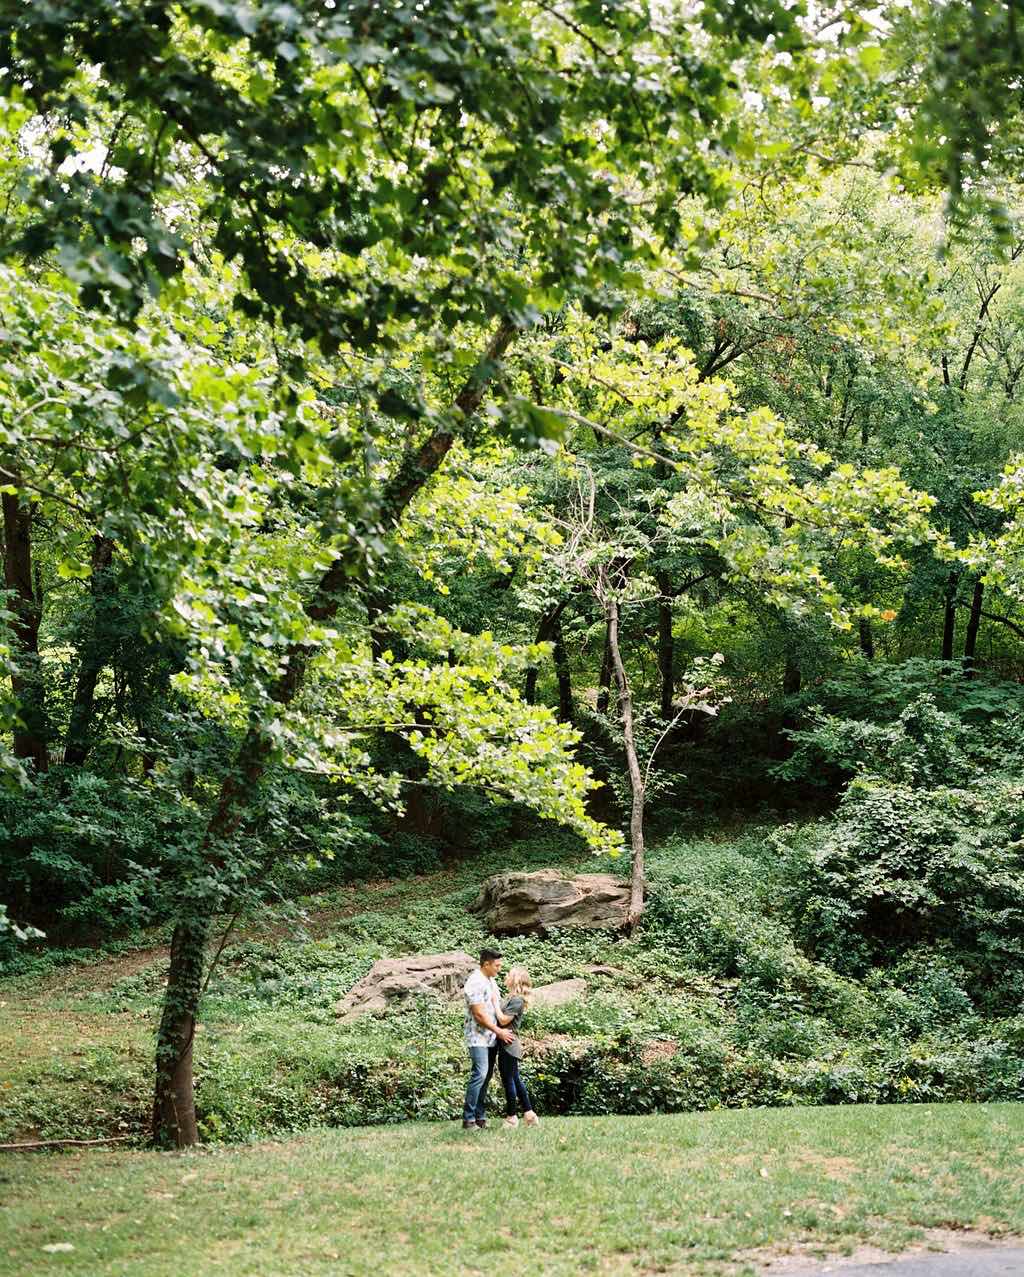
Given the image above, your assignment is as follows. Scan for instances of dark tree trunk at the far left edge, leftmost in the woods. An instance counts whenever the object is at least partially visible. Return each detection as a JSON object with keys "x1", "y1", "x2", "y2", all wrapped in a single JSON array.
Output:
[{"x1": 3, "y1": 493, "x2": 50, "y2": 771}]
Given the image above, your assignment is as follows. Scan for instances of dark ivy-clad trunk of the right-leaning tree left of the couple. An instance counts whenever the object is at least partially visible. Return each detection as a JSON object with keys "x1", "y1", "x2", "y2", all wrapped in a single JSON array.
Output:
[{"x1": 153, "y1": 321, "x2": 516, "y2": 1148}]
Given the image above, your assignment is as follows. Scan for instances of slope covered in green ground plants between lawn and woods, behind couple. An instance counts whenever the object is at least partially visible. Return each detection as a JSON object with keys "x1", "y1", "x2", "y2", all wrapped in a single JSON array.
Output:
[{"x1": 0, "y1": 829, "x2": 1024, "y2": 1142}]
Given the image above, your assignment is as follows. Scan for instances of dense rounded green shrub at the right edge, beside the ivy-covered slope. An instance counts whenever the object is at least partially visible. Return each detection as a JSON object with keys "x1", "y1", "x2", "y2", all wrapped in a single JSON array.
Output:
[{"x1": 781, "y1": 778, "x2": 1024, "y2": 1006}]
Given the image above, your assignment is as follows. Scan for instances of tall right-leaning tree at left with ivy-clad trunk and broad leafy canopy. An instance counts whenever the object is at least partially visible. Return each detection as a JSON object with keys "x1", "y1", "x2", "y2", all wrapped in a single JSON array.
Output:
[{"x1": 0, "y1": 0, "x2": 1011, "y2": 1144}]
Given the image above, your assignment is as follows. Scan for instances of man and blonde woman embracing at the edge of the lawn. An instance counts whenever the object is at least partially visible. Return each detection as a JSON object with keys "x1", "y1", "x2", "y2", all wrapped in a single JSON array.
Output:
[{"x1": 462, "y1": 949, "x2": 540, "y2": 1130}]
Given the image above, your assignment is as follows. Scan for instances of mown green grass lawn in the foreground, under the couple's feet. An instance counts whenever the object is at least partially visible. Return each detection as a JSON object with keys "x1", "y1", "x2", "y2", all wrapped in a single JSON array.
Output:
[{"x1": 0, "y1": 1105, "x2": 1024, "y2": 1277}]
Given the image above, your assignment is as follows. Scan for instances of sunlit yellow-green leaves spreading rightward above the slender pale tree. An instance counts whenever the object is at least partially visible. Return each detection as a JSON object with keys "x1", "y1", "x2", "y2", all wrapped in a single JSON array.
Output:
[{"x1": 538, "y1": 321, "x2": 942, "y2": 628}]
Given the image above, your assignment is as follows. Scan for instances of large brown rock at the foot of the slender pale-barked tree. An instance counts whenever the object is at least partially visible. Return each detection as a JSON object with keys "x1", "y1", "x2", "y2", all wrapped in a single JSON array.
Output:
[{"x1": 470, "y1": 870, "x2": 629, "y2": 936}]
